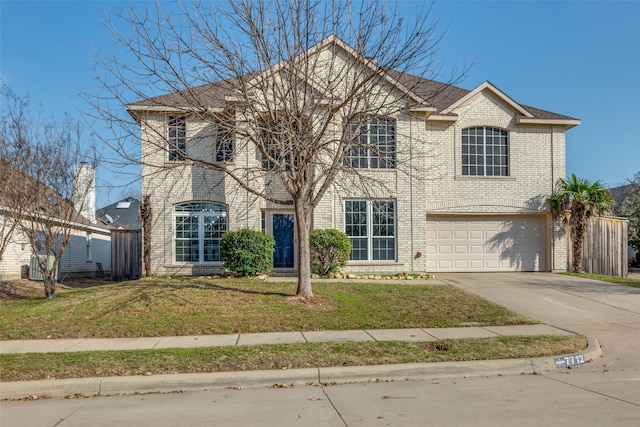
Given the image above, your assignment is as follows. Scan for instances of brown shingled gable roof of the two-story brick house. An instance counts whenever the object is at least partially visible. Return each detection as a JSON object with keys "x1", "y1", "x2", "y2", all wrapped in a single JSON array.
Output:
[{"x1": 127, "y1": 36, "x2": 580, "y2": 129}]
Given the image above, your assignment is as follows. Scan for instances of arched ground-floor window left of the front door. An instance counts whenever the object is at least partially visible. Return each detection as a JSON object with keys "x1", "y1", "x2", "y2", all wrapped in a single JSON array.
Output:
[{"x1": 174, "y1": 202, "x2": 228, "y2": 264}]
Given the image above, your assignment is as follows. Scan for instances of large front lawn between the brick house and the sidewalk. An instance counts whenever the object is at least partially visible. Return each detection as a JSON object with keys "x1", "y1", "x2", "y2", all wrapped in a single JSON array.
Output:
[{"x1": 0, "y1": 277, "x2": 536, "y2": 339}]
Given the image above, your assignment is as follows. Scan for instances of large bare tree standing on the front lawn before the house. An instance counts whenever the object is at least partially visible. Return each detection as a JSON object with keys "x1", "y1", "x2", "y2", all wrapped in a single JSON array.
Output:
[{"x1": 93, "y1": 0, "x2": 464, "y2": 297}]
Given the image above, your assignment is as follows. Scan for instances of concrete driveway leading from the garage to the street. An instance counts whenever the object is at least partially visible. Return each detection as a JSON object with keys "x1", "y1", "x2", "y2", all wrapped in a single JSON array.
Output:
[{"x1": 436, "y1": 273, "x2": 640, "y2": 371}]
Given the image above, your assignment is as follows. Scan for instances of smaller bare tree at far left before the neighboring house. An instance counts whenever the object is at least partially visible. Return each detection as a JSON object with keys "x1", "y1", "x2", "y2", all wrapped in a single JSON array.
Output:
[{"x1": 0, "y1": 85, "x2": 95, "y2": 298}]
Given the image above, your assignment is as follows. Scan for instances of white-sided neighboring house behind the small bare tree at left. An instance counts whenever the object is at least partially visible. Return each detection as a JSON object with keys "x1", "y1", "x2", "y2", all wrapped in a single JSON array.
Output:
[{"x1": 0, "y1": 164, "x2": 111, "y2": 280}]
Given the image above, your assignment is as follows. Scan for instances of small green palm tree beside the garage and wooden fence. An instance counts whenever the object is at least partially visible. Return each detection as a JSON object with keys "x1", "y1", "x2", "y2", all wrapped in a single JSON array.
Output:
[{"x1": 548, "y1": 174, "x2": 615, "y2": 271}]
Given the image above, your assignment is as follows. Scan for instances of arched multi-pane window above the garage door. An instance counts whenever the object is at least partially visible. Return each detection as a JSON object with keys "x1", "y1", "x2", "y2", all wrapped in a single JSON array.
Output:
[{"x1": 462, "y1": 127, "x2": 509, "y2": 176}]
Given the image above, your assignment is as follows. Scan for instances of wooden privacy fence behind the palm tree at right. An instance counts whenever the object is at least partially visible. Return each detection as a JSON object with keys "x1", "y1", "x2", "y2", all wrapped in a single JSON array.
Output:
[{"x1": 567, "y1": 217, "x2": 629, "y2": 277}]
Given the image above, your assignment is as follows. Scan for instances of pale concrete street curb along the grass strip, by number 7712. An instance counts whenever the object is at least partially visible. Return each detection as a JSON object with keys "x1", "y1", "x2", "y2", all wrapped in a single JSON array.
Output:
[{"x1": 0, "y1": 337, "x2": 602, "y2": 400}]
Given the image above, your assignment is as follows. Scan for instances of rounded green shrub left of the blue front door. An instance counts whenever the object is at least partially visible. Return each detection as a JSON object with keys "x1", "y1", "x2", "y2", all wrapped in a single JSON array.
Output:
[{"x1": 220, "y1": 228, "x2": 275, "y2": 276}]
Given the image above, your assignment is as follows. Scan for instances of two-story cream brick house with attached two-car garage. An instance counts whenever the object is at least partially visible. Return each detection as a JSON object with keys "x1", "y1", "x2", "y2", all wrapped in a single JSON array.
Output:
[{"x1": 127, "y1": 39, "x2": 580, "y2": 274}]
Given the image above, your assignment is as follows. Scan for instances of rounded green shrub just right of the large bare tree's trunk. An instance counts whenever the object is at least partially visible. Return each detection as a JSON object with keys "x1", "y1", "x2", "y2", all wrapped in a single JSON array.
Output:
[{"x1": 310, "y1": 229, "x2": 351, "y2": 275}]
